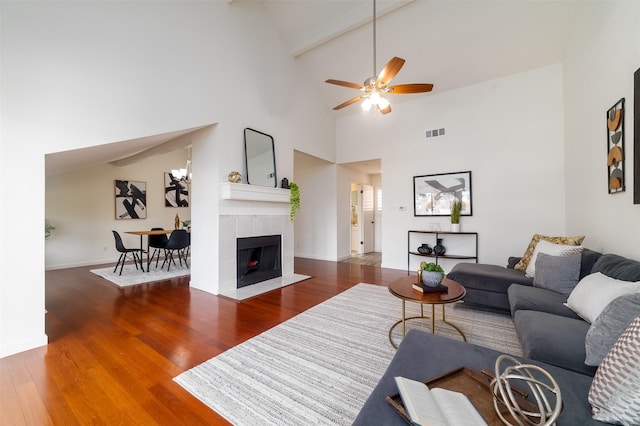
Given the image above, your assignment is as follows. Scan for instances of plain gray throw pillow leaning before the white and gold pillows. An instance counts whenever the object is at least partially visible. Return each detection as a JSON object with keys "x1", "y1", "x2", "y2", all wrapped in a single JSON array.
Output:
[{"x1": 533, "y1": 253, "x2": 582, "y2": 294}]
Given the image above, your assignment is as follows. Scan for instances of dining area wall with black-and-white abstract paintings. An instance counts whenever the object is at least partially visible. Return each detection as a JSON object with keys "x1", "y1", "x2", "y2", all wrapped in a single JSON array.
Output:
[{"x1": 45, "y1": 149, "x2": 191, "y2": 269}]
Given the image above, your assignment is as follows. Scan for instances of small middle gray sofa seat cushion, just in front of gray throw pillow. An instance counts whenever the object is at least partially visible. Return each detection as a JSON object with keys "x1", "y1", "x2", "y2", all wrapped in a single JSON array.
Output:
[{"x1": 508, "y1": 284, "x2": 580, "y2": 319}]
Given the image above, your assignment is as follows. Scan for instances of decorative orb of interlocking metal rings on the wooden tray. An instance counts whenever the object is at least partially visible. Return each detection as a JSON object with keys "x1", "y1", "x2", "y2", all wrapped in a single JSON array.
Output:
[{"x1": 490, "y1": 355, "x2": 562, "y2": 426}]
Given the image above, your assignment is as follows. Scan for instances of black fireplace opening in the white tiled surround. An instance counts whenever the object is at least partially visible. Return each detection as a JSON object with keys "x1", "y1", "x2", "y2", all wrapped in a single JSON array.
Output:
[{"x1": 237, "y1": 235, "x2": 282, "y2": 288}]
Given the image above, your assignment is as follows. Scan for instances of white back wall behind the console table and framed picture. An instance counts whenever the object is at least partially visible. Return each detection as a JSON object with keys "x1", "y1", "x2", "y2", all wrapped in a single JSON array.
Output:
[{"x1": 336, "y1": 65, "x2": 564, "y2": 269}]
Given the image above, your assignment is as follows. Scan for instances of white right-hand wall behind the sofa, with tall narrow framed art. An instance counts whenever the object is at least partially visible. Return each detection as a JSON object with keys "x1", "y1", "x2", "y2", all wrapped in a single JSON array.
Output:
[{"x1": 564, "y1": 1, "x2": 640, "y2": 260}]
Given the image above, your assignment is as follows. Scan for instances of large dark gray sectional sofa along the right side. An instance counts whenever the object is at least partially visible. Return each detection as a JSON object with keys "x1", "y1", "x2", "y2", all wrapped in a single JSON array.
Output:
[{"x1": 354, "y1": 249, "x2": 640, "y2": 425}]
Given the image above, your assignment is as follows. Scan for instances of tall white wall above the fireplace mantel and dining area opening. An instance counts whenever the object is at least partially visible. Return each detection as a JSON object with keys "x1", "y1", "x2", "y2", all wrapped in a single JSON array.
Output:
[{"x1": 0, "y1": 1, "x2": 335, "y2": 356}]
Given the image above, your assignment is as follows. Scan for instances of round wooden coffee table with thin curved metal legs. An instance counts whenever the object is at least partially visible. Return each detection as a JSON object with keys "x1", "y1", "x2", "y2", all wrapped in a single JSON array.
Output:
[{"x1": 389, "y1": 275, "x2": 467, "y2": 349}]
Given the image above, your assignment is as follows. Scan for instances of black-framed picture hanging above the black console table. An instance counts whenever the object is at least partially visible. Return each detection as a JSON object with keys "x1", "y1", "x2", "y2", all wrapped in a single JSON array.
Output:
[{"x1": 413, "y1": 171, "x2": 473, "y2": 216}]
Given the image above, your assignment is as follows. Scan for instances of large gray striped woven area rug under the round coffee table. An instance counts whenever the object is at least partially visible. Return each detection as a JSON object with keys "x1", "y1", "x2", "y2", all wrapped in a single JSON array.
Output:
[{"x1": 174, "y1": 284, "x2": 520, "y2": 425}]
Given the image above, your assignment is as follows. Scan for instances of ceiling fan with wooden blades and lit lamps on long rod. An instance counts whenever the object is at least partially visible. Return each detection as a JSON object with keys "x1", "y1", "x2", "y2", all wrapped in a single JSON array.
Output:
[{"x1": 325, "y1": 0, "x2": 433, "y2": 114}]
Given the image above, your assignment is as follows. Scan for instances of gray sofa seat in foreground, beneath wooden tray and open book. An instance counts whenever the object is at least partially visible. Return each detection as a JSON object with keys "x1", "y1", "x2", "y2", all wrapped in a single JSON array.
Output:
[{"x1": 353, "y1": 330, "x2": 603, "y2": 426}]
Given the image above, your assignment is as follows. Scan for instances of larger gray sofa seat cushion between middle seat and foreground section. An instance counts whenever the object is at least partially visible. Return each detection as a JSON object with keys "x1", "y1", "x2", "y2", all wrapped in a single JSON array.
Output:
[{"x1": 513, "y1": 310, "x2": 595, "y2": 375}]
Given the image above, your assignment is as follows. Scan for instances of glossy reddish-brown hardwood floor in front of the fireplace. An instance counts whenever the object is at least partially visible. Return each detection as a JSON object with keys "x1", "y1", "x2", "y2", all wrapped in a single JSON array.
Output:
[{"x1": 0, "y1": 259, "x2": 406, "y2": 425}]
